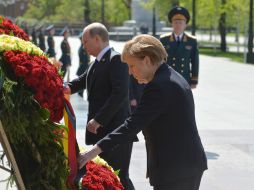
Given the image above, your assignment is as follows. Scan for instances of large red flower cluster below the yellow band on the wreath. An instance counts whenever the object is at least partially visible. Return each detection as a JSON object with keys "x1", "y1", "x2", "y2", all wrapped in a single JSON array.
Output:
[{"x1": 3, "y1": 51, "x2": 64, "y2": 122}]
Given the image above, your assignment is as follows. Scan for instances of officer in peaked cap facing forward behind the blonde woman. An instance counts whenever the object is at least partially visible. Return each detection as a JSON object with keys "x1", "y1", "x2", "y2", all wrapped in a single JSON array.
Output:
[{"x1": 160, "y1": 6, "x2": 199, "y2": 88}]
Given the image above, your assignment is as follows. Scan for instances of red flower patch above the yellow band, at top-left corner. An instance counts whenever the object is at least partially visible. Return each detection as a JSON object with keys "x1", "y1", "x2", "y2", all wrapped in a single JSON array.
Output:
[{"x1": 0, "y1": 16, "x2": 29, "y2": 41}]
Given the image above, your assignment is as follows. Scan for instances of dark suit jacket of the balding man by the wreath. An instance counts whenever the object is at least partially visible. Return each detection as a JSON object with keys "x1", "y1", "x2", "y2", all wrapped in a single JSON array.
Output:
[{"x1": 69, "y1": 49, "x2": 130, "y2": 144}]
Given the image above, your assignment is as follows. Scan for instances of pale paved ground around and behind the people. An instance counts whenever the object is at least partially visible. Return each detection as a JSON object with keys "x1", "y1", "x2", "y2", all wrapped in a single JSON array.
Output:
[{"x1": 0, "y1": 39, "x2": 254, "y2": 190}]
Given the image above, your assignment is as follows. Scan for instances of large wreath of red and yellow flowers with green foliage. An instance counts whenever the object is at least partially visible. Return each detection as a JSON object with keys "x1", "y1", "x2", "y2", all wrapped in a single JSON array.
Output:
[{"x1": 0, "y1": 16, "x2": 123, "y2": 190}]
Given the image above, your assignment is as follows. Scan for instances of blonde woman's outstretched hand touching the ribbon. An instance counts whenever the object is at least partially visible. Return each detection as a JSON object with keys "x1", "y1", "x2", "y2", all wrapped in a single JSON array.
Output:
[{"x1": 78, "y1": 145, "x2": 102, "y2": 169}]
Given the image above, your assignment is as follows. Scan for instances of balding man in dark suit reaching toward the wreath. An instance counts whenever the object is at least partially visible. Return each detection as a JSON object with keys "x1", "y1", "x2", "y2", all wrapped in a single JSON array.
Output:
[{"x1": 65, "y1": 23, "x2": 135, "y2": 190}]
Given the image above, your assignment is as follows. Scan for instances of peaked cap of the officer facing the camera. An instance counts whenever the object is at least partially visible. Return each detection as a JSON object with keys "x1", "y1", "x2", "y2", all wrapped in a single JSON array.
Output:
[{"x1": 168, "y1": 6, "x2": 190, "y2": 23}]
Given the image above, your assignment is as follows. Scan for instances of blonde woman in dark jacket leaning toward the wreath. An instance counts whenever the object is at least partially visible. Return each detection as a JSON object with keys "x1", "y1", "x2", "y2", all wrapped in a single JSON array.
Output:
[{"x1": 79, "y1": 35, "x2": 207, "y2": 190}]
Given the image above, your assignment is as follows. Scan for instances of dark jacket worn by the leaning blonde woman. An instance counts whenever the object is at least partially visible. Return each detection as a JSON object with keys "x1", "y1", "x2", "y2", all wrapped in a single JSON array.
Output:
[{"x1": 97, "y1": 64, "x2": 207, "y2": 186}]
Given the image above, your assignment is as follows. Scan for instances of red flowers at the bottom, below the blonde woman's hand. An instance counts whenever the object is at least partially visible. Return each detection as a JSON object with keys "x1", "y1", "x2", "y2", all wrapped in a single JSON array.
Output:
[{"x1": 81, "y1": 161, "x2": 124, "y2": 190}]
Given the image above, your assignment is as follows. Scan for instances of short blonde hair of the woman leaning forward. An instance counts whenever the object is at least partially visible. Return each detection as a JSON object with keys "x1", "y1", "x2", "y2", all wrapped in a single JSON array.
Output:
[{"x1": 121, "y1": 34, "x2": 168, "y2": 64}]
